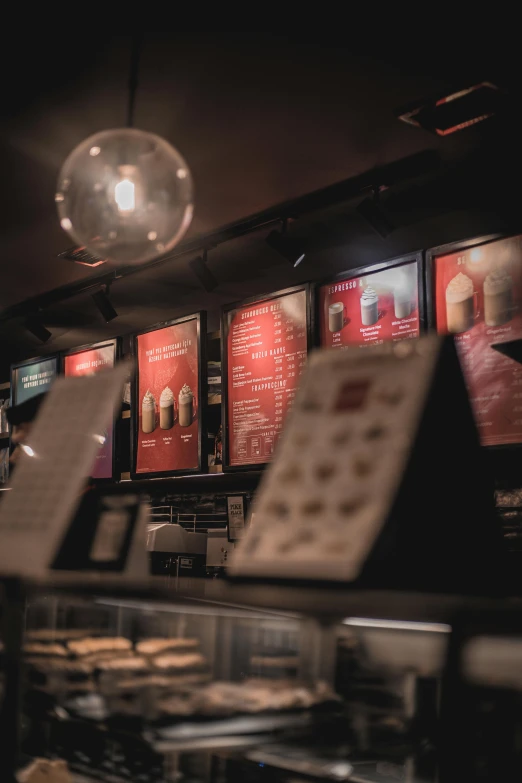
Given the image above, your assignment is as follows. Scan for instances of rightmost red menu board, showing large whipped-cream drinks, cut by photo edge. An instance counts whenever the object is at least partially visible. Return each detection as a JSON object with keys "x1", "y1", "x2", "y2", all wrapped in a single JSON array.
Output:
[{"x1": 428, "y1": 236, "x2": 522, "y2": 446}]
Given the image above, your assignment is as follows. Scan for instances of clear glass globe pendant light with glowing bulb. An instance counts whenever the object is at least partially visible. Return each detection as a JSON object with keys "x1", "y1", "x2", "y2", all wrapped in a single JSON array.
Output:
[{"x1": 55, "y1": 128, "x2": 194, "y2": 264}]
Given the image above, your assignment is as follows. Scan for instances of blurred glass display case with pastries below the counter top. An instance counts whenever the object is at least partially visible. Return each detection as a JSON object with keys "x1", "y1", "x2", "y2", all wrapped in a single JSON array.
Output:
[{"x1": 0, "y1": 580, "x2": 516, "y2": 783}]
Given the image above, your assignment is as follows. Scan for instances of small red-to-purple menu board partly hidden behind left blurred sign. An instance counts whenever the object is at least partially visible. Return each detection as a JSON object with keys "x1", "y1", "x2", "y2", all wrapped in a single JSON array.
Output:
[{"x1": 63, "y1": 340, "x2": 117, "y2": 479}]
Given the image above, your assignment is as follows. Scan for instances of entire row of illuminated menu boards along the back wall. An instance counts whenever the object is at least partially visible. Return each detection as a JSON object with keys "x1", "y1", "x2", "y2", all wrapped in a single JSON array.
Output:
[{"x1": 12, "y1": 230, "x2": 522, "y2": 479}]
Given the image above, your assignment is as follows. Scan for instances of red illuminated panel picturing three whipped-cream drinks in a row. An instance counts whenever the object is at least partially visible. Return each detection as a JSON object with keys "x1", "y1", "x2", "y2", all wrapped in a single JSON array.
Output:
[{"x1": 132, "y1": 313, "x2": 206, "y2": 476}]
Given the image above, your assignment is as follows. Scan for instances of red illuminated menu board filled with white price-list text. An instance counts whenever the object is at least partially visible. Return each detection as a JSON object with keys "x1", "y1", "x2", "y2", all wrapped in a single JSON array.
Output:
[{"x1": 222, "y1": 286, "x2": 309, "y2": 470}]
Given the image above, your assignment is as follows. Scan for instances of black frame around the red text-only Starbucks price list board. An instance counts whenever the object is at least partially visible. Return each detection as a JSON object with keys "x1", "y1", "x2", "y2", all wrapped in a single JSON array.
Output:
[{"x1": 221, "y1": 283, "x2": 315, "y2": 473}]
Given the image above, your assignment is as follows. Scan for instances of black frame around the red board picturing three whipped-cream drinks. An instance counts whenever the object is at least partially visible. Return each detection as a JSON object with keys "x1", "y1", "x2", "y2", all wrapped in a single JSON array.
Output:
[{"x1": 130, "y1": 310, "x2": 207, "y2": 481}]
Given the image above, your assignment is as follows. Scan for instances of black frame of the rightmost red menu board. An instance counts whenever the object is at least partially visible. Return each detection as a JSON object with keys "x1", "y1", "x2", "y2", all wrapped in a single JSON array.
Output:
[{"x1": 425, "y1": 231, "x2": 522, "y2": 454}]
